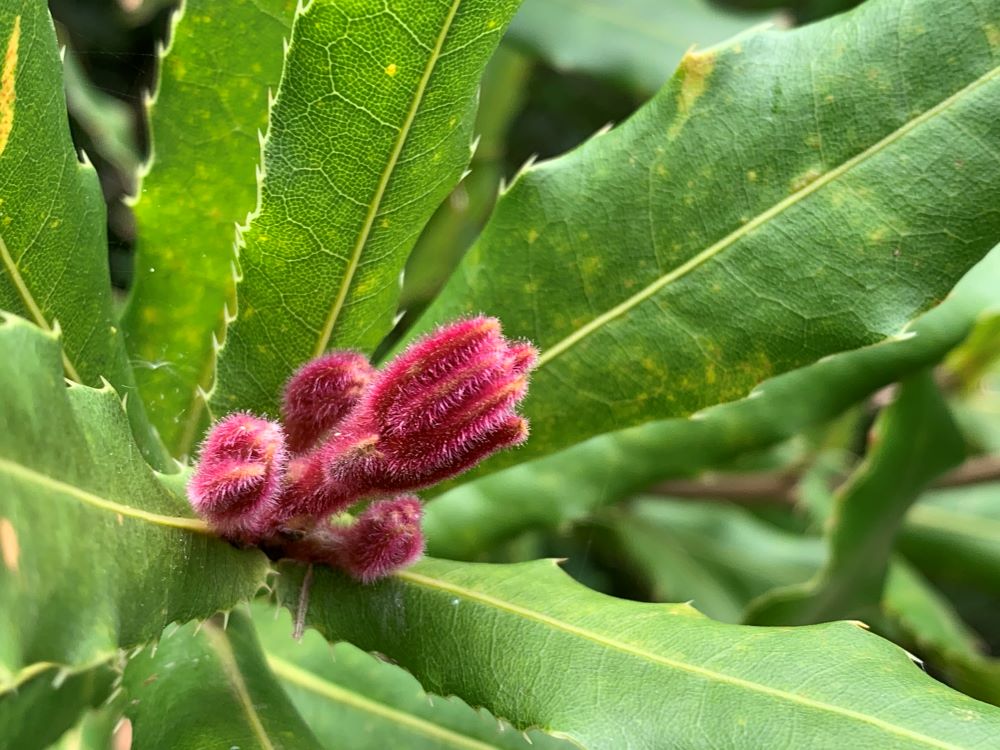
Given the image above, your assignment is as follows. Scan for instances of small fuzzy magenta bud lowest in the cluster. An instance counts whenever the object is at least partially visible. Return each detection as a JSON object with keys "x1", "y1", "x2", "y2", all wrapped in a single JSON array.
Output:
[{"x1": 334, "y1": 495, "x2": 424, "y2": 583}]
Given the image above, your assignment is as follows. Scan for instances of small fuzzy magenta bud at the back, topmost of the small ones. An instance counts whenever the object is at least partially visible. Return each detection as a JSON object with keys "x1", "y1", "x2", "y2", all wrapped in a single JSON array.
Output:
[{"x1": 281, "y1": 351, "x2": 375, "y2": 453}]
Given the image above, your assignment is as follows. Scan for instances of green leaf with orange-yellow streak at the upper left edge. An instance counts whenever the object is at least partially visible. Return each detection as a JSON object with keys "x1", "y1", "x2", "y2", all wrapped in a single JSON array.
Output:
[{"x1": 0, "y1": 0, "x2": 168, "y2": 468}]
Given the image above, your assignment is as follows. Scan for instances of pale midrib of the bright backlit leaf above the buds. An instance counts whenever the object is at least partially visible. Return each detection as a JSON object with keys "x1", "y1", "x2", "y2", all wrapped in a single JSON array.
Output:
[{"x1": 313, "y1": 0, "x2": 462, "y2": 357}]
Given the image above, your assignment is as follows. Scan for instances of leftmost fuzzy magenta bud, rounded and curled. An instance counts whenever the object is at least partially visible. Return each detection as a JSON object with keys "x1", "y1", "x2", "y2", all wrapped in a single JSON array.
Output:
[{"x1": 188, "y1": 412, "x2": 288, "y2": 543}]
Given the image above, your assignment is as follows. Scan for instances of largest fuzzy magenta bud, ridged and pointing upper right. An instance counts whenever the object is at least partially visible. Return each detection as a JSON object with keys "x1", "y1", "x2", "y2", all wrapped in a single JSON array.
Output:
[{"x1": 317, "y1": 317, "x2": 537, "y2": 497}]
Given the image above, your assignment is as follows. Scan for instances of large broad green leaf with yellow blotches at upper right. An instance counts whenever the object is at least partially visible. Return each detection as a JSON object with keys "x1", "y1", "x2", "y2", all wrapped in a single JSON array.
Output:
[{"x1": 406, "y1": 0, "x2": 1000, "y2": 482}]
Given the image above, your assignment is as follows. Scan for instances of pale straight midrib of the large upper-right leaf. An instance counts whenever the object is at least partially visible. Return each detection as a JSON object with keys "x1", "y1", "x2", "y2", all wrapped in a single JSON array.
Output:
[{"x1": 538, "y1": 60, "x2": 1000, "y2": 367}]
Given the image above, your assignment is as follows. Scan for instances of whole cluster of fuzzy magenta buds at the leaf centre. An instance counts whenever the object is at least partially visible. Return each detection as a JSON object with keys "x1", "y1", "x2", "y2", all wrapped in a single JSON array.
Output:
[{"x1": 188, "y1": 317, "x2": 537, "y2": 582}]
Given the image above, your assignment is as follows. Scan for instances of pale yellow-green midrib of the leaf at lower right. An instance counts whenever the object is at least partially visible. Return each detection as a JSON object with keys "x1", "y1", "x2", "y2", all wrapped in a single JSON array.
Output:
[{"x1": 396, "y1": 571, "x2": 963, "y2": 750}]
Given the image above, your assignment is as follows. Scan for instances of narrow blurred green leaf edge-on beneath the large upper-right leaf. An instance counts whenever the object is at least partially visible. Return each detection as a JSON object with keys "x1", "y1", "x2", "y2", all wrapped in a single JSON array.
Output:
[{"x1": 424, "y1": 247, "x2": 1000, "y2": 560}]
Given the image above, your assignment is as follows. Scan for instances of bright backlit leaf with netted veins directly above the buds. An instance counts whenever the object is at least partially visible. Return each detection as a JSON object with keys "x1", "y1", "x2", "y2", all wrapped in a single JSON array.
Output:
[{"x1": 210, "y1": 0, "x2": 518, "y2": 414}]
